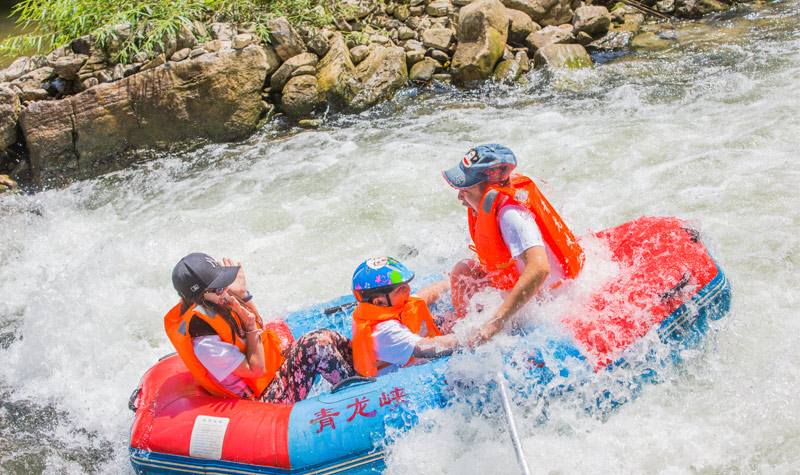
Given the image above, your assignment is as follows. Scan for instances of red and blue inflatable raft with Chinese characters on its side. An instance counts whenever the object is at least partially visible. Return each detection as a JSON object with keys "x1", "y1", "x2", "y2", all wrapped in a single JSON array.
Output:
[{"x1": 130, "y1": 218, "x2": 730, "y2": 475}]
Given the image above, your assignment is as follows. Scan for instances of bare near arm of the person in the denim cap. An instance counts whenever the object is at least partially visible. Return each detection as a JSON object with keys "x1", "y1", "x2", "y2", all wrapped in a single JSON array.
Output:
[{"x1": 470, "y1": 246, "x2": 550, "y2": 346}]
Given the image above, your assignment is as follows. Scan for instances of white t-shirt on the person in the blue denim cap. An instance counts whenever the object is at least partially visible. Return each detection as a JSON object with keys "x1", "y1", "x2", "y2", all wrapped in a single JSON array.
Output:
[{"x1": 498, "y1": 205, "x2": 564, "y2": 288}]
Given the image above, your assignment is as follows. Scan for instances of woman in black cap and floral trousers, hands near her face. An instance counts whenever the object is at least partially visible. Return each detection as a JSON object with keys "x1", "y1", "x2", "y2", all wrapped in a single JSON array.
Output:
[{"x1": 164, "y1": 253, "x2": 355, "y2": 404}]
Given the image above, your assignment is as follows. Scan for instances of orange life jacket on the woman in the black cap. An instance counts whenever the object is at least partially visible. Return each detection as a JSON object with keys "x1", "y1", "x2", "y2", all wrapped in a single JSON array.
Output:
[{"x1": 164, "y1": 303, "x2": 283, "y2": 398}]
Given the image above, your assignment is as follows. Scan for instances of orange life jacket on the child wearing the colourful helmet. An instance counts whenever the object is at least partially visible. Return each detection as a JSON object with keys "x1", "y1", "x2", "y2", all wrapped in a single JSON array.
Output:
[{"x1": 353, "y1": 297, "x2": 442, "y2": 377}]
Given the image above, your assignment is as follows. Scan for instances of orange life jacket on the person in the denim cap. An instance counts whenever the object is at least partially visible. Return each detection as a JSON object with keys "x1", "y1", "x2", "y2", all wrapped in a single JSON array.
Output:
[{"x1": 467, "y1": 175, "x2": 584, "y2": 290}]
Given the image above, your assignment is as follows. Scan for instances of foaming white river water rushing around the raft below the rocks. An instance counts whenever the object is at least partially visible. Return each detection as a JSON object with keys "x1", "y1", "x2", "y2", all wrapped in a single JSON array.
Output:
[{"x1": 0, "y1": 1, "x2": 800, "y2": 474}]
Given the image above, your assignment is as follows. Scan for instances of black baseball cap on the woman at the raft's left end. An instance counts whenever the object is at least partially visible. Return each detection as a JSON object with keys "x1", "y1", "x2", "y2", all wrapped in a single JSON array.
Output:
[{"x1": 172, "y1": 252, "x2": 239, "y2": 302}]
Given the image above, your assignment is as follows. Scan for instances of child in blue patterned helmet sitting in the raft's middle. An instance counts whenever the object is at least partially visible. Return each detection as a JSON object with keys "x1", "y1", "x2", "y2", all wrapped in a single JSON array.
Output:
[{"x1": 353, "y1": 257, "x2": 461, "y2": 377}]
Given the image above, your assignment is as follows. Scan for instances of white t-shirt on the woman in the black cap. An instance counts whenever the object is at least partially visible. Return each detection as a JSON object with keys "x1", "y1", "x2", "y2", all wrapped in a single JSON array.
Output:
[{"x1": 192, "y1": 335, "x2": 248, "y2": 394}]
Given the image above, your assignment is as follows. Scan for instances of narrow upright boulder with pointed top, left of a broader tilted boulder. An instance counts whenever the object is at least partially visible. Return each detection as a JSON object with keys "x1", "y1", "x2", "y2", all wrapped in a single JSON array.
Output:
[{"x1": 317, "y1": 33, "x2": 355, "y2": 106}]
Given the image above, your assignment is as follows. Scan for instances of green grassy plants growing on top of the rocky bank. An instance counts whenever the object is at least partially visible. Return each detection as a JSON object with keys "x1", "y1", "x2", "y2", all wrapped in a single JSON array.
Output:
[{"x1": 0, "y1": 0, "x2": 336, "y2": 62}]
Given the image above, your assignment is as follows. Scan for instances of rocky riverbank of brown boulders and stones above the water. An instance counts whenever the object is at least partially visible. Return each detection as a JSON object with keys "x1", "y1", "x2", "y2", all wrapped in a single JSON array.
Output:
[{"x1": 0, "y1": 0, "x2": 730, "y2": 191}]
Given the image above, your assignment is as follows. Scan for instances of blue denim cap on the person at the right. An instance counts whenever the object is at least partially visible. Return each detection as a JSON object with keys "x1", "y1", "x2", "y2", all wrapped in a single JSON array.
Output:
[{"x1": 442, "y1": 143, "x2": 517, "y2": 188}]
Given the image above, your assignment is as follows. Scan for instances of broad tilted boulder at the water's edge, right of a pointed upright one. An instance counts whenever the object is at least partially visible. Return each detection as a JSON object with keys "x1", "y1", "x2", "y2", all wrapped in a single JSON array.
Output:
[{"x1": 350, "y1": 46, "x2": 408, "y2": 110}]
